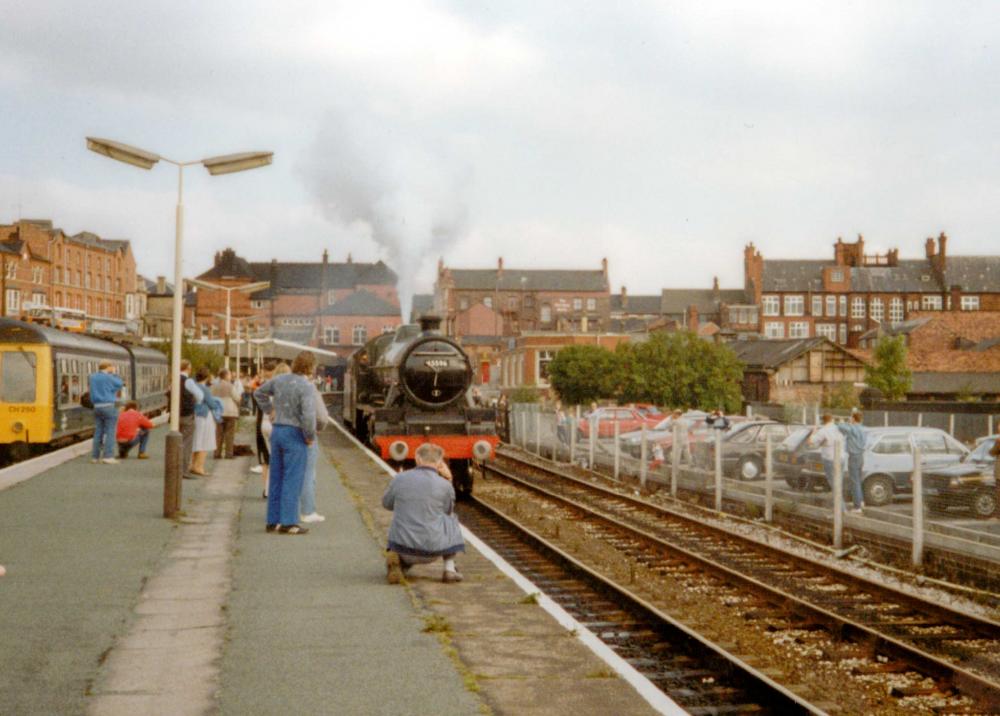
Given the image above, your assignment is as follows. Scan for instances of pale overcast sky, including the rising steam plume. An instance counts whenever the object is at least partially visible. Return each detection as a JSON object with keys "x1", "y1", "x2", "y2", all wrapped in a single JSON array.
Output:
[{"x1": 0, "y1": 0, "x2": 1000, "y2": 314}]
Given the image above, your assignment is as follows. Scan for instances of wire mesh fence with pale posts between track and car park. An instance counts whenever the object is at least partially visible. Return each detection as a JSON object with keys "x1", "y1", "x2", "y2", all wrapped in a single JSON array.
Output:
[{"x1": 508, "y1": 403, "x2": 1000, "y2": 566}]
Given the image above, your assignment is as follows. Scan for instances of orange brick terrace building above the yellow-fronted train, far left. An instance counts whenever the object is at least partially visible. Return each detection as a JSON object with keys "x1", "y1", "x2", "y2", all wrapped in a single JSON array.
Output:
[{"x1": 0, "y1": 219, "x2": 144, "y2": 323}]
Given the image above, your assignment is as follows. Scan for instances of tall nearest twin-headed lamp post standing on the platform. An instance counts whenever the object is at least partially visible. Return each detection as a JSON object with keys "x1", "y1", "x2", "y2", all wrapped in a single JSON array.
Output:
[{"x1": 87, "y1": 137, "x2": 274, "y2": 517}]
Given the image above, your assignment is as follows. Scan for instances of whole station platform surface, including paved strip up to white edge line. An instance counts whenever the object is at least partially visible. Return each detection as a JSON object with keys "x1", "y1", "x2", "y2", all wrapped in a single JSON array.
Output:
[{"x1": 0, "y1": 428, "x2": 655, "y2": 716}]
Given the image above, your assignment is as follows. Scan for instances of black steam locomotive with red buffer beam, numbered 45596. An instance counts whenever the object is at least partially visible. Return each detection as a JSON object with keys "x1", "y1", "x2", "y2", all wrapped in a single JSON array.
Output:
[{"x1": 343, "y1": 316, "x2": 499, "y2": 495}]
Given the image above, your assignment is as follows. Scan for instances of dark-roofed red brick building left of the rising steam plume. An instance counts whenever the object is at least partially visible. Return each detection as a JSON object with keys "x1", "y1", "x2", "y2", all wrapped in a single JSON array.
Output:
[{"x1": 193, "y1": 249, "x2": 401, "y2": 357}]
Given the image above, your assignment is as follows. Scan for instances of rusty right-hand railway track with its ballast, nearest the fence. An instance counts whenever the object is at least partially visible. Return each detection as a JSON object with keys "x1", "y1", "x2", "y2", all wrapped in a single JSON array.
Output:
[{"x1": 479, "y1": 455, "x2": 1000, "y2": 713}]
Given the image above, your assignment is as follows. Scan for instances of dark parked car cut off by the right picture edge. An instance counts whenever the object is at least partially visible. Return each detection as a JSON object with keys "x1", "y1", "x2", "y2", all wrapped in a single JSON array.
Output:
[{"x1": 924, "y1": 435, "x2": 1000, "y2": 519}]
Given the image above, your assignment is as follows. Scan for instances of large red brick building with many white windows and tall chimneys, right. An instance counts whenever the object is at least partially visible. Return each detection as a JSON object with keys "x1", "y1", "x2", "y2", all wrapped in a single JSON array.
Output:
[{"x1": 743, "y1": 233, "x2": 1000, "y2": 346}]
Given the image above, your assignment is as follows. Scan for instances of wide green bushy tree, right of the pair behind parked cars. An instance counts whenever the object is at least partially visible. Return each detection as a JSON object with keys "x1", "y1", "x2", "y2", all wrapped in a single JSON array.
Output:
[{"x1": 617, "y1": 331, "x2": 743, "y2": 412}]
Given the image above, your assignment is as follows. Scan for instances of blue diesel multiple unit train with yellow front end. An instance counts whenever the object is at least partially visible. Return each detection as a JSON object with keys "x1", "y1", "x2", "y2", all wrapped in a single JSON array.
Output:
[{"x1": 0, "y1": 319, "x2": 170, "y2": 462}]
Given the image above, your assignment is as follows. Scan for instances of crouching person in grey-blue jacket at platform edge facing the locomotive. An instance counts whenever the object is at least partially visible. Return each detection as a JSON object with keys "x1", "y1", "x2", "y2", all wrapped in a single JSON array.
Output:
[{"x1": 382, "y1": 443, "x2": 465, "y2": 584}]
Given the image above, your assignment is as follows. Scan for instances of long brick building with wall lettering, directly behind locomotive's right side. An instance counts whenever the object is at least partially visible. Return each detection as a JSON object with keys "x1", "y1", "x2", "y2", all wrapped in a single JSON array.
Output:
[{"x1": 434, "y1": 258, "x2": 611, "y2": 336}]
